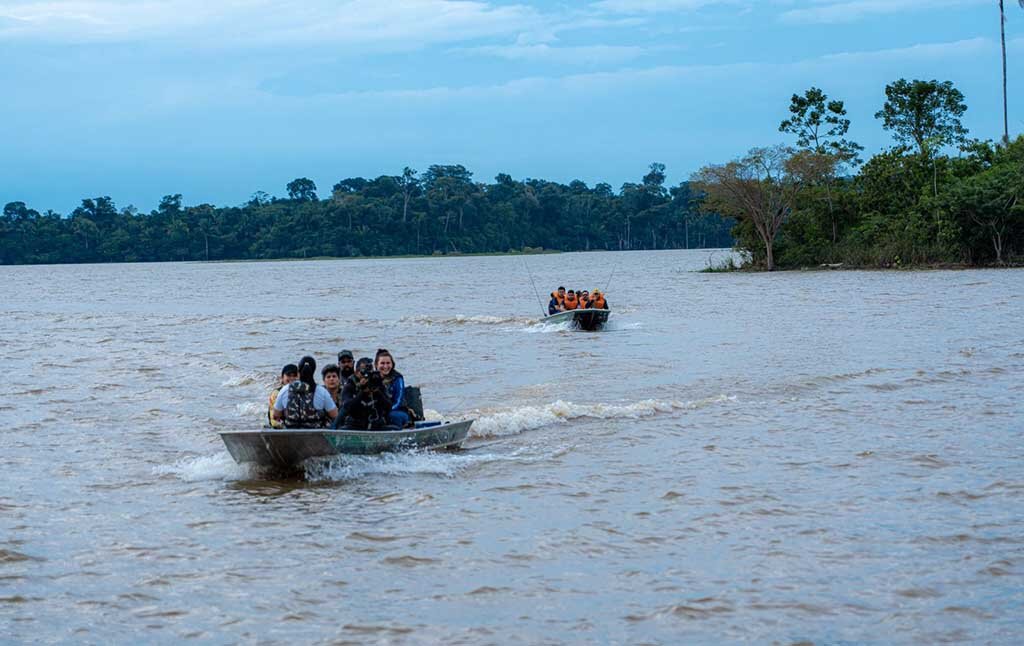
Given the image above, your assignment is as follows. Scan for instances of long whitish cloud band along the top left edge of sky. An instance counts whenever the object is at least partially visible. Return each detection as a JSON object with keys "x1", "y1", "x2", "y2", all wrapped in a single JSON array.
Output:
[{"x1": 0, "y1": 0, "x2": 544, "y2": 48}]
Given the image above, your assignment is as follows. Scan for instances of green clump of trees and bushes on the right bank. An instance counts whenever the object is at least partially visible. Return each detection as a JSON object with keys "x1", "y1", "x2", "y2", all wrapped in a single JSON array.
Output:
[{"x1": 690, "y1": 79, "x2": 1024, "y2": 271}]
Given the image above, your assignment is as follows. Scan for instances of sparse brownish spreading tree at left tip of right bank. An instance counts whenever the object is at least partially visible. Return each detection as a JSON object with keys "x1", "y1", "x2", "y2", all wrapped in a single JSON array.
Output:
[{"x1": 691, "y1": 145, "x2": 837, "y2": 271}]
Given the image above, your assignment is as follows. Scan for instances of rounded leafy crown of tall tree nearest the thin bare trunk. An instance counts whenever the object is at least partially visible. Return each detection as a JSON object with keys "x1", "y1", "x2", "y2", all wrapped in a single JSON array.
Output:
[{"x1": 874, "y1": 79, "x2": 968, "y2": 156}]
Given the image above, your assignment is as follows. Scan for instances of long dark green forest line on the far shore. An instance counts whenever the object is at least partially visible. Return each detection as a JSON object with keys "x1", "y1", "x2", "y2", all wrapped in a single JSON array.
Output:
[{"x1": 0, "y1": 163, "x2": 735, "y2": 264}]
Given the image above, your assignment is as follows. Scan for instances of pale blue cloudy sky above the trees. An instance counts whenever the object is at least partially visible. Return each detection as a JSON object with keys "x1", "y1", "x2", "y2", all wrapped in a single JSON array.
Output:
[{"x1": 0, "y1": 0, "x2": 1024, "y2": 213}]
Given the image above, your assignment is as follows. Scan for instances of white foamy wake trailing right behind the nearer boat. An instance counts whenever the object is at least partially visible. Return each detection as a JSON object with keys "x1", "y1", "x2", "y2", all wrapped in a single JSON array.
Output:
[{"x1": 470, "y1": 395, "x2": 736, "y2": 437}]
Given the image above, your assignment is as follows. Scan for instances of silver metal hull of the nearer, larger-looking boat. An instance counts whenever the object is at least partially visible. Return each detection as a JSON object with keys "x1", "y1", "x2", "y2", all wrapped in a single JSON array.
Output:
[{"x1": 220, "y1": 420, "x2": 473, "y2": 468}]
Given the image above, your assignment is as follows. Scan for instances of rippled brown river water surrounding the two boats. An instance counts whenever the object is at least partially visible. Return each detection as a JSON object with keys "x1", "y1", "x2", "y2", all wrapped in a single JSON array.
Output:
[{"x1": 0, "y1": 251, "x2": 1024, "y2": 644}]
